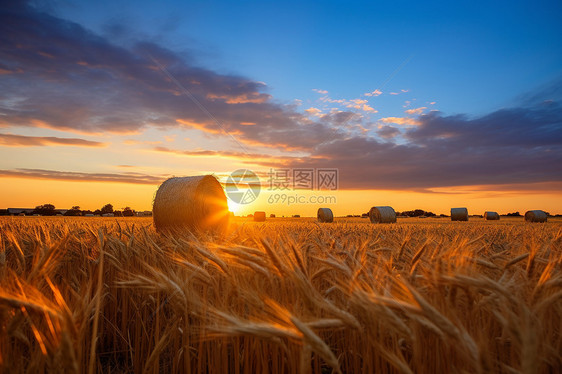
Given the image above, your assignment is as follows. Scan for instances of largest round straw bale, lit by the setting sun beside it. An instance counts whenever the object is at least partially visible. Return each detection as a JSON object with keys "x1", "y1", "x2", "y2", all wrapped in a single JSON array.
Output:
[{"x1": 152, "y1": 175, "x2": 229, "y2": 232}]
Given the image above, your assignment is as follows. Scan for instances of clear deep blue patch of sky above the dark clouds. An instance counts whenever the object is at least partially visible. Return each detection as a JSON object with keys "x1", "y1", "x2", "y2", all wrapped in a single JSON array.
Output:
[{"x1": 50, "y1": 1, "x2": 562, "y2": 116}]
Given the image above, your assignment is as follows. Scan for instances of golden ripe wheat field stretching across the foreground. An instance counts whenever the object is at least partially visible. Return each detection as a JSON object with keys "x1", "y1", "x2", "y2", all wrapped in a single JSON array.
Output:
[{"x1": 0, "y1": 217, "x2": 562, "y2": 373}]
